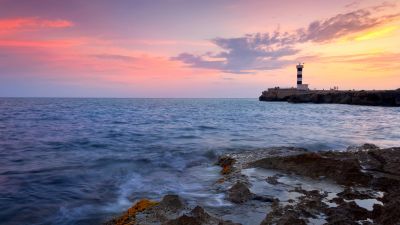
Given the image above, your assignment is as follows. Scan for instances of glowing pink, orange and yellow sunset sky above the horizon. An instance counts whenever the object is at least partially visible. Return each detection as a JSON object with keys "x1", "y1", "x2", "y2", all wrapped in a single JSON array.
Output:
[{"x1": 0, "y1": 0, "x2": 400, "y2": 97}]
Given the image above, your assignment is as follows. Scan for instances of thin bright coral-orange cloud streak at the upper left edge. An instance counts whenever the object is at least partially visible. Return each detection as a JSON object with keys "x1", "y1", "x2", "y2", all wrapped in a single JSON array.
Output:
[{"x1": 0, "y1": 17, "x2": 74, "y2": 30}]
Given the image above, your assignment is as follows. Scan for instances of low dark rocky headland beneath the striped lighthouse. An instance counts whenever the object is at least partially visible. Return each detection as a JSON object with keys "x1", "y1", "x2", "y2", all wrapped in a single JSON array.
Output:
[{"x1": 259, "y1": 89, "x2": 400, "y2": 107}]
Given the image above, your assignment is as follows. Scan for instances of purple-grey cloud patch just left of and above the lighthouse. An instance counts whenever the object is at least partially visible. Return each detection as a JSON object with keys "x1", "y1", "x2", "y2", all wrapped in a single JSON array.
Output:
[{"x1": 172, "y1": 32, "x2": 298, "y2": 74}]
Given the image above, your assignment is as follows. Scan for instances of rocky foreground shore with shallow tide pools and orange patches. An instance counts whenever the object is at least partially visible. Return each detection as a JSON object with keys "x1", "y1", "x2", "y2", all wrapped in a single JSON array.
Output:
[{"x1": 105, "y1": 144, "x2": 400, "y2": 225}]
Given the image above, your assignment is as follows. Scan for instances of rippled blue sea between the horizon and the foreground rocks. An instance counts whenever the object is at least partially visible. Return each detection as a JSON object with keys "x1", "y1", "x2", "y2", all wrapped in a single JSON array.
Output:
[{"x1": 0, "y1": 98, "x2": 400, "y2": 224}]
